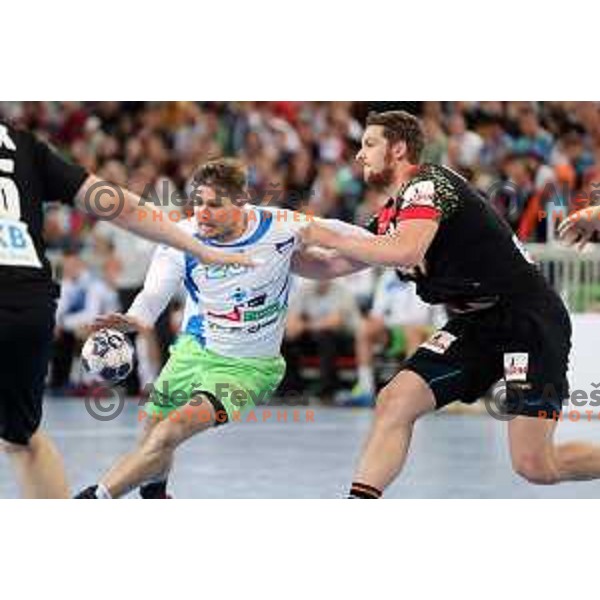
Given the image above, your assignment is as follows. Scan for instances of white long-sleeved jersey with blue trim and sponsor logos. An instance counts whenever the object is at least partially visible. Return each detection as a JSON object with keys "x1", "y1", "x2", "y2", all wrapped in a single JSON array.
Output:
[{"x1": 128, "y1": 206, "x2": 358, "y2": 358}]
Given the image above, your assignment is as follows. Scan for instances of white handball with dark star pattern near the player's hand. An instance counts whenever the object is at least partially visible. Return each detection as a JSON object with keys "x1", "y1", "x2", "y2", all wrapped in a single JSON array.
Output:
[{"x1": 81, "y1": 329, "x2": 133, "y2": 383}]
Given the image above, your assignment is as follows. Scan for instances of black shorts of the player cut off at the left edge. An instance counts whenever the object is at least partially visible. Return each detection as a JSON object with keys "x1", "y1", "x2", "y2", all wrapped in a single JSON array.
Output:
[{"x1": 0, "y1": 301, "x2": 55, "y2": 444}]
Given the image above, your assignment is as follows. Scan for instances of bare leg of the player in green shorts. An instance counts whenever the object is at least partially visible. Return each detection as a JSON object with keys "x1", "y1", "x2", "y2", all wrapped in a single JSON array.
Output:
[{"x1": 94, "y1": 396, "x2": 217, "y2": 498}]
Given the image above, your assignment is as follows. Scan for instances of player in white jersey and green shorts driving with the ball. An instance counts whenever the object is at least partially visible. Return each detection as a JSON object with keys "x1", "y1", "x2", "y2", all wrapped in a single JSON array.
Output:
[{"x1": 76, "y1": 159, "x2": 372, "y2": 499}]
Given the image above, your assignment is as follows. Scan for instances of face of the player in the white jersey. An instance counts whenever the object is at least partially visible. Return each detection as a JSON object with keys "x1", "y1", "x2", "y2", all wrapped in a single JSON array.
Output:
[{"x1": 194, "y1": 185, "x2": 243, "y2": 240}]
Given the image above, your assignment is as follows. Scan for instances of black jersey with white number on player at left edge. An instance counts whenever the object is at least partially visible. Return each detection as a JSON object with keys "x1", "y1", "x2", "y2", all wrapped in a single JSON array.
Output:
[{"x1": 0, "y1": 121, "x2": 87, "y2": 307}]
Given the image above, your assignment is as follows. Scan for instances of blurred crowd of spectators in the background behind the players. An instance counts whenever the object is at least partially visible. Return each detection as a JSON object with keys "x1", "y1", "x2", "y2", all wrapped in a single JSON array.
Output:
[{"x1": 0, "y1": 101, "x2": 600, "y2": 400}]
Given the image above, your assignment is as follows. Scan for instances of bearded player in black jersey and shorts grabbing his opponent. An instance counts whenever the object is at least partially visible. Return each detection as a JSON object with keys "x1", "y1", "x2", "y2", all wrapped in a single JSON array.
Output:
[{"x1": 304, "y1": 111, "x2": 600, "y2": 498}]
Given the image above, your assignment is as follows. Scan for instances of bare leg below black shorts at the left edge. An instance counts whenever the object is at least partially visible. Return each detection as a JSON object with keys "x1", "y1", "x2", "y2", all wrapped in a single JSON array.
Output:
[{"x1": 2, "y1": 429, "x2": 69, "y2": 498}]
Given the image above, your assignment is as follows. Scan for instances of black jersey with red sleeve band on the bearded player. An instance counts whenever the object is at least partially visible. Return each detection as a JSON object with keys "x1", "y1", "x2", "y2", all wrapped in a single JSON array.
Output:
[{"x1": 368, "y1": 164, "x2": 558, "y2": 310}]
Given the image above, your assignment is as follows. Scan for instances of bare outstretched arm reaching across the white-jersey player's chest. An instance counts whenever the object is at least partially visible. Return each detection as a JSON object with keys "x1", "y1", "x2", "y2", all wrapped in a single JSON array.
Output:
[{"x1": 75, "y1": 175, "x2": 253, "y2": 266}]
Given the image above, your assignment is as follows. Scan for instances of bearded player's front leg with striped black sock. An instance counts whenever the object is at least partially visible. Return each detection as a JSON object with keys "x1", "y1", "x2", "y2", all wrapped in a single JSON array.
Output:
[{"x1": 350, "y1": 370, "x2": 436, "y2": 497}]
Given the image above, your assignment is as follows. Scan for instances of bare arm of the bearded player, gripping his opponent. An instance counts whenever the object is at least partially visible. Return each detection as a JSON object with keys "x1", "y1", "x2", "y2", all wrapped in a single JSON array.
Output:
[{"x1": 300, "y1": 219, "x2": 438, "y2": 267}]
